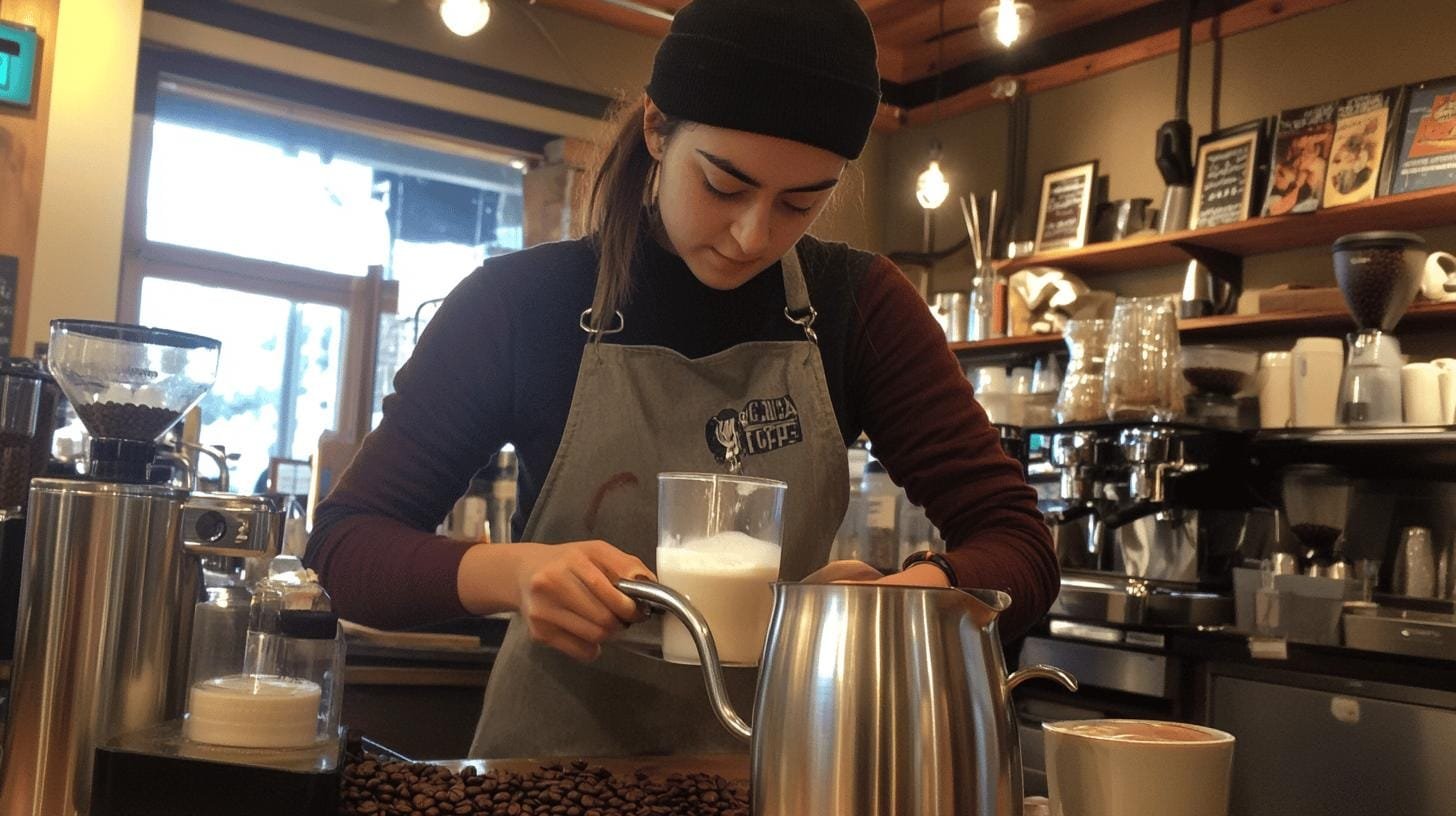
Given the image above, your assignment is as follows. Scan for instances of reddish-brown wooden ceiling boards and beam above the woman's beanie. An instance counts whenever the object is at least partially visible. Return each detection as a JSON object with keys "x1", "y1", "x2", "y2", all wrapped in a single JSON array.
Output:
[{"x1": 529, "y1": 0, "x2": 1345, "y2": 130}]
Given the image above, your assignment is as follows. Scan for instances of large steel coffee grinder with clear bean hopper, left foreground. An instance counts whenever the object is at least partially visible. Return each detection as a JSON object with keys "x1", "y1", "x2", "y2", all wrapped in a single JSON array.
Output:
[{"x1": 0, "y1": 321, "x2": 282, "y2": 816}]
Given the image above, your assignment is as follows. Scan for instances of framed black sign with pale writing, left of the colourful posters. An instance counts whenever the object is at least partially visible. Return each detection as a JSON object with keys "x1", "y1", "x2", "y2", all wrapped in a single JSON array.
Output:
[{"x1": 1188, "y1": 119, "x2": 1267, "y2": 229}]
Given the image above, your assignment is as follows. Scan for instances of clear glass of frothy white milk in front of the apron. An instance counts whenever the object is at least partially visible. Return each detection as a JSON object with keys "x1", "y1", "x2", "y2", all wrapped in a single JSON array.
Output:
[{"x1": 657, "y1": 474, "x2": 788, "y2": 666}]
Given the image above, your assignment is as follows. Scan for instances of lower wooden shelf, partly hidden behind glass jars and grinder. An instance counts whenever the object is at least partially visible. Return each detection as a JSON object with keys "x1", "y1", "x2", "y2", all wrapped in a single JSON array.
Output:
[{"x1": 951, "y1": 303, "x2": 1456, "y2": 356}]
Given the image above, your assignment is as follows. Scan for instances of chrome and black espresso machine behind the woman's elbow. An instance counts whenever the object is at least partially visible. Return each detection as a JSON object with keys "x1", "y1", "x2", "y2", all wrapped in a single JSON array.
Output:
[{"x1": 1029, "y1": 423, "x2": 1257, "y2": 627}]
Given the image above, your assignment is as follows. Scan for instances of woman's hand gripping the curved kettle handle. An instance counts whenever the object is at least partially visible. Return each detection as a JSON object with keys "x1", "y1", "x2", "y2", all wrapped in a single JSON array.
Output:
[{"x1": 459, "y1": 541, "x2": 657, "y2": 663}]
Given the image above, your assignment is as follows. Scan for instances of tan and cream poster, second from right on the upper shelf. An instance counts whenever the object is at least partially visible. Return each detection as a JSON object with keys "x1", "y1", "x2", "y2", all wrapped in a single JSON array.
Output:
[{"x1": 1321, "y1": 87, "x2": 1401, "y2": 207}]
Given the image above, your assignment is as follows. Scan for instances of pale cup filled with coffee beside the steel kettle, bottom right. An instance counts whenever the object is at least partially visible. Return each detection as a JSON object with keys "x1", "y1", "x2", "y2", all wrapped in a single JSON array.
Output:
[{"x1": 1042, "y1": 720, "x2": 1233, "y2": 816}]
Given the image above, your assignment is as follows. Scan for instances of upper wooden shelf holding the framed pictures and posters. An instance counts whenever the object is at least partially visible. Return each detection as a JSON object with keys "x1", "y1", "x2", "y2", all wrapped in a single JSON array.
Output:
[{"x1": 1000, "y1": 187, "x2": 1456, "y2": 275}]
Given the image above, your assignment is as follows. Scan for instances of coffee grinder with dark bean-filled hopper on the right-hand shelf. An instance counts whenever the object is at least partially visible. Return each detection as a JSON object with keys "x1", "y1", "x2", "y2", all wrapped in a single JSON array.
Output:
[{"x1": 1334, "y1": 232, "x2": 1425, "y2": 425}]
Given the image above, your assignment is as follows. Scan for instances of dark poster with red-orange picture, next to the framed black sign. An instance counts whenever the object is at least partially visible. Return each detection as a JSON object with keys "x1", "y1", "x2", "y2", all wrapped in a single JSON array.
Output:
[{"x1": 1264, "y1": 102, "x2": 1335, "y2": 216}]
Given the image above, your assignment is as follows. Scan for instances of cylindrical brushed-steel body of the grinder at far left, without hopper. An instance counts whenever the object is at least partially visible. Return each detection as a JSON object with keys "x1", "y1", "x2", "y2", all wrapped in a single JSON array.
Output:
[{"x1": 0, "y1": 479, "x2": 190, "y2": 816}]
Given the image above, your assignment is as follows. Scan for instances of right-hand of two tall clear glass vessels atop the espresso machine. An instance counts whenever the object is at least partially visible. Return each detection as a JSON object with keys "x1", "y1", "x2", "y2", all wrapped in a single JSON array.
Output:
[{"x1": 1102, "y1": 297, "x2": 1182, "y2": 421}]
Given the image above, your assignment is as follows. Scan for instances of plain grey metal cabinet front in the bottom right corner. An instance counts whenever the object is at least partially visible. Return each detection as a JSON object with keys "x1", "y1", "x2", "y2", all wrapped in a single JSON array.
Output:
[{"x1": 1210, "y1": 669, "x2": 1456, "y2": 816}]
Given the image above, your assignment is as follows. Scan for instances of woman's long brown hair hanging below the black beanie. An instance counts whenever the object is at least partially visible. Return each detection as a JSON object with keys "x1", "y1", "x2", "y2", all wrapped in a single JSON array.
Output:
[{"x1": 581, "y1": 96, "x2": 683, "y2": 329}]
